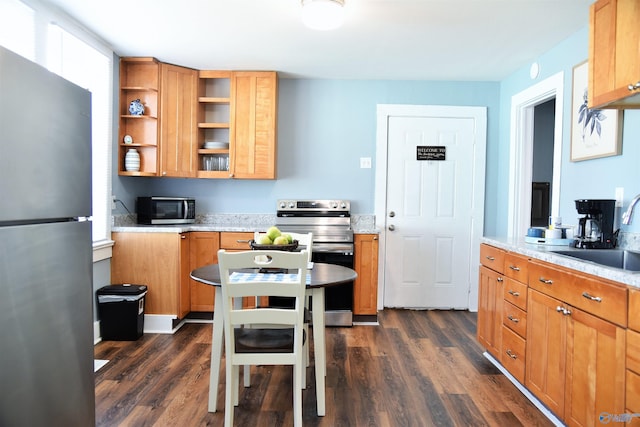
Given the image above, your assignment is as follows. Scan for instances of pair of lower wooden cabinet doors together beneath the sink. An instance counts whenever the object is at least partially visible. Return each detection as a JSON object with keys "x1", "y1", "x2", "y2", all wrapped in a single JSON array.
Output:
[{"x1": 525, "y1": 289, "x2": 626, "y2": 426}]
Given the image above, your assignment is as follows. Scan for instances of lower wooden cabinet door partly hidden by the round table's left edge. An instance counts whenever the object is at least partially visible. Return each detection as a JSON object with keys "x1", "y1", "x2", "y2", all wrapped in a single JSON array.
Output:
[{"x1": 189, "y1": 231, "x2": 220, "y2": 312}]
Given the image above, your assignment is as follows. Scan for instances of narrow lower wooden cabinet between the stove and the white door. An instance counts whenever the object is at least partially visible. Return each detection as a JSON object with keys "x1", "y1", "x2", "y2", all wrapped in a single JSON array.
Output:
[{"x1": 353, "y1": 234, "x2": 378, "y2": 316}]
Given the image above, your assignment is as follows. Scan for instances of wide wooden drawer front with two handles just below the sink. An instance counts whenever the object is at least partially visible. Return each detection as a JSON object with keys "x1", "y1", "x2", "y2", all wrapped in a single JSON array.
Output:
[{"x1": 529, "y1": 261, "x2": 627, "y2": 327}]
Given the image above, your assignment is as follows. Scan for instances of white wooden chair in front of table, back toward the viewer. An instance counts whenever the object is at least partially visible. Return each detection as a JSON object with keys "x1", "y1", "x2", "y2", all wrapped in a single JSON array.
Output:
[{"x1": 218, "y1": 250, "x2": 308, "y2": 427}]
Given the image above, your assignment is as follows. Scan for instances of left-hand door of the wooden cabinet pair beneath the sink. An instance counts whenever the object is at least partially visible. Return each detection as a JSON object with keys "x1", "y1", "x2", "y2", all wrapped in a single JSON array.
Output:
[{"x1": 525, "y1": 289, "x2": 567, "y2": 417}]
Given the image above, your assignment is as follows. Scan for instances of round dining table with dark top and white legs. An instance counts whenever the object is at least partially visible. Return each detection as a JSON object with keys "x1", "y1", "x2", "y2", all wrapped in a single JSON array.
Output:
[{"x1": 191, "y1": 262, "x2": 358, "y2": 416}]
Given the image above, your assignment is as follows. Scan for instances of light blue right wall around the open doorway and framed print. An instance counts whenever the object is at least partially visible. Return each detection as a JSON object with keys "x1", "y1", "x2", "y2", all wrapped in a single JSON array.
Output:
[{"x1": 498, "y1": 27, "x2": 640, "y2": 236}]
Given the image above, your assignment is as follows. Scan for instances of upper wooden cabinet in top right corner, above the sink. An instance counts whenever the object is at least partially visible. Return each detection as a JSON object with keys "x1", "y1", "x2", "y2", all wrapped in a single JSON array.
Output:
[{"x1": 589, "y1": 0, "x2": 640, "y2": 108}]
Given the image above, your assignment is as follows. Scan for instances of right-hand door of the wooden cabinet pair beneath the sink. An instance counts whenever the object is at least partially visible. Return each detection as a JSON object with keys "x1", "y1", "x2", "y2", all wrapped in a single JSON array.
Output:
[{"x1": 565, "y1": 309, "x2": 626, "y2": 426}]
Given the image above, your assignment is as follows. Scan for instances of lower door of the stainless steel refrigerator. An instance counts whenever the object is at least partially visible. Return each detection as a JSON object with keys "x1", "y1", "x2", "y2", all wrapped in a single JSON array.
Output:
[{"x1": 0, "y1": 221, "x2": 95, "y2": 426}]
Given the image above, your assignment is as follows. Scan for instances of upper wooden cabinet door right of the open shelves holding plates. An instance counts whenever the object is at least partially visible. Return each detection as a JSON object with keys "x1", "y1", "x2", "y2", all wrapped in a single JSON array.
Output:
[{"x1": 230, "y1": 71, "x2": 278, "y2": 179}]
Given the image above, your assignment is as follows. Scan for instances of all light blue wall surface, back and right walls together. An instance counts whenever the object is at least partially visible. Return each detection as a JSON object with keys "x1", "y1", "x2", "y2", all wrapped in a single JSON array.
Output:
[{"x1": 113, "y1": 27, "x2": 640, "y2": 236}]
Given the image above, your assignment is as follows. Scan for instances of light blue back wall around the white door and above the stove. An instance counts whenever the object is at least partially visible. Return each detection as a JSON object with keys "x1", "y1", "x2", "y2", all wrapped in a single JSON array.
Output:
[{"x1": 113, "y1": 79, "x2": 499, "y2": 227}]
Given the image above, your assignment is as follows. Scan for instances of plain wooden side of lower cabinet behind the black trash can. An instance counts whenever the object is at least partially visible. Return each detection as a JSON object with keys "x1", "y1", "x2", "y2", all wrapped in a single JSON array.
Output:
[{"x1": 111, "y1": 233, "x2": 190, "y2": 318}]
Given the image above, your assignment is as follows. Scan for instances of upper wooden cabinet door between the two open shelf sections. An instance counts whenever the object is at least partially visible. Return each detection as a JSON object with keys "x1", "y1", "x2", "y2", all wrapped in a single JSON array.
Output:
[{"x1": 159, "y1": 64, "x2": 198, "y2": 178}]
